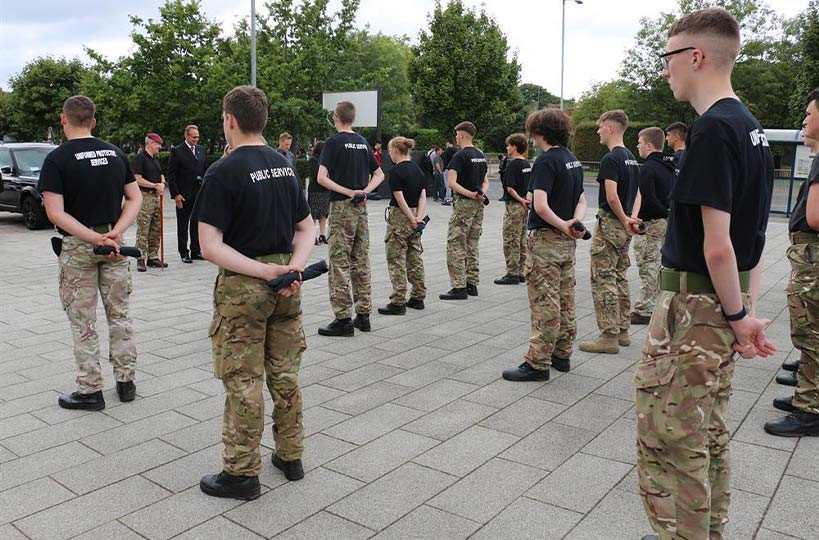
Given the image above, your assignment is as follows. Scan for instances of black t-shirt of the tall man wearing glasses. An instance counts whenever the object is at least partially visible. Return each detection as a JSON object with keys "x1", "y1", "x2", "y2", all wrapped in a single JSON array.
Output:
[{"x1": 662, "y1": 98, "x2": 774, "y2": 275}]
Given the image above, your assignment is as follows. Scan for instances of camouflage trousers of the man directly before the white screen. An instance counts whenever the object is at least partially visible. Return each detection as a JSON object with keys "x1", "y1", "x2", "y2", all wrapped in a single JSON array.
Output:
[{"x1": 327, "y1": 201, "x2": 372, "y2": 319}]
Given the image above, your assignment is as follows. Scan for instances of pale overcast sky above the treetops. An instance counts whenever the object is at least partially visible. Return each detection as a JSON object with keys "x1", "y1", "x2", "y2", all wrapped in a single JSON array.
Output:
[{"x1": 0, "y1": 0, "x2": 808, "y2": 97}]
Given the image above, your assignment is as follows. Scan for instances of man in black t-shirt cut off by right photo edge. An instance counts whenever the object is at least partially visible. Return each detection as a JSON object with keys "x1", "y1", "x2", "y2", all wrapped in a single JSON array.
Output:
[{"x1": 765, "y1": 88, "x2": 819, "y2": 437}]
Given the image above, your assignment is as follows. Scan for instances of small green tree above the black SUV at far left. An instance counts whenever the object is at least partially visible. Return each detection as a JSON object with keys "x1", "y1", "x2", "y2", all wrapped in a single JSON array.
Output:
[{"x1": 8, "y1": 56, "x2": 87, "y2": 140}]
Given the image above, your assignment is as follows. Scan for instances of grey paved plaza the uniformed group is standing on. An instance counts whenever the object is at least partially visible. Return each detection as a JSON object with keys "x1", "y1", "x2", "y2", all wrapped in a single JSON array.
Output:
[{"x1": 0, "y1": 183, "x2": 819, "y2": 540}]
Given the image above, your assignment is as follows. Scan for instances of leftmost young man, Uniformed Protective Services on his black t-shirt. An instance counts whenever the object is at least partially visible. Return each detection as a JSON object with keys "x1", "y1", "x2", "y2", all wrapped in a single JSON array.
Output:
[{"x1": 38, "y1": 96, "x2": 142, "y2": 411}]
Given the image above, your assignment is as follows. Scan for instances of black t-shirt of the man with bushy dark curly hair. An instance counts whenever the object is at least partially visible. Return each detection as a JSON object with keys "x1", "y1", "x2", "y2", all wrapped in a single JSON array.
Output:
[{"x1": 527, "y1": 146, "x2": 583, "y2": 230}]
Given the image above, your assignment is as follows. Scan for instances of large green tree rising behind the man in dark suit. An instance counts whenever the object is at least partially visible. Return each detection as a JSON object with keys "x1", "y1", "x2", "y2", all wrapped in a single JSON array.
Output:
[{"x1": 85, "y1": 0, "x2": 226, "y2": 148}]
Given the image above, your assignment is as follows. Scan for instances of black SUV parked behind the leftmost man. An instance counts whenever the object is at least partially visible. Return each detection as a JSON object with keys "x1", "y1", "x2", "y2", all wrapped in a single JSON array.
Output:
[{"x1": 0, "y1": 143, "x2": 56, "y2": 229}]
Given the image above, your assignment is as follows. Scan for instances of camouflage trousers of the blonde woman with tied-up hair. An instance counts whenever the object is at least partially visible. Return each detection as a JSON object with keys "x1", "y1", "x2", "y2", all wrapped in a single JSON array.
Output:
[{"x1": 384, "y1": 207, "x2": 427, "y2": 306}]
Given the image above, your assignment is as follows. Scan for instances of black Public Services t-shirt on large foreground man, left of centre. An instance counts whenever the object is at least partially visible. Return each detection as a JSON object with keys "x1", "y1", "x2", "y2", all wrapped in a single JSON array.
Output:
[{"x1": 193, "y1": 145, "x2": 310, "y2": 257}]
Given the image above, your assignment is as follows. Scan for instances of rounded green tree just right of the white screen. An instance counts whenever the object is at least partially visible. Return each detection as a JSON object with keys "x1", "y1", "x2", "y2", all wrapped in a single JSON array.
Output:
[{"x1": 409, "y1": 0, "x2": 523, "y2": 141}]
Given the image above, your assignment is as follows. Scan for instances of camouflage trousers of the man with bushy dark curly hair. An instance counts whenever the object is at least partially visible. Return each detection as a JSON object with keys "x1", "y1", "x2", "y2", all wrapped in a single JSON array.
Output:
[{"x1": 524, "y1": 229, "x2": 577, "y2": 369}]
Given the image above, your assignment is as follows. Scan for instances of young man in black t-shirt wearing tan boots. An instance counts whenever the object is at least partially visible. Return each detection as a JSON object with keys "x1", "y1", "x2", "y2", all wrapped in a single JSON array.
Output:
[{"x1": 580, "y1": 110, "x2": 640, "y2": 354}]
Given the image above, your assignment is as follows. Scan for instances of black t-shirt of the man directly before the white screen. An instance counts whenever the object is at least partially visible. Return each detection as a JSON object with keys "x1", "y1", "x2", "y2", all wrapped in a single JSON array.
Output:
[{"x1": 319, "y1": 131, "x2": 378, "y2": 201}]
